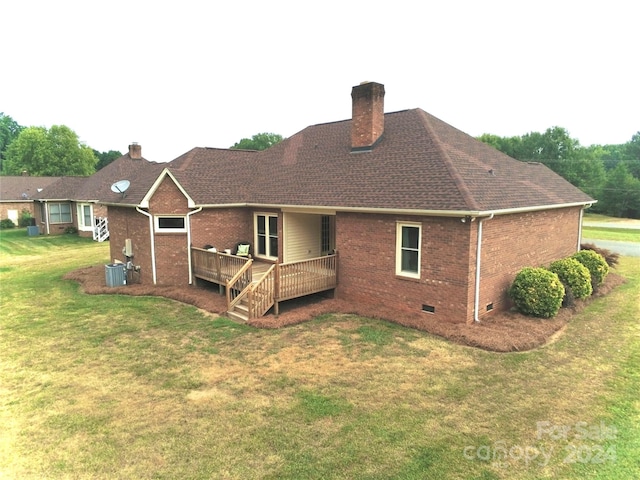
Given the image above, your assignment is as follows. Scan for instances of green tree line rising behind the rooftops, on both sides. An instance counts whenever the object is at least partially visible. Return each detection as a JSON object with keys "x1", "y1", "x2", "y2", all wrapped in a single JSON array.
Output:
[{"x1": 0, "y1": 112, "x2": 640, "y2": 218}]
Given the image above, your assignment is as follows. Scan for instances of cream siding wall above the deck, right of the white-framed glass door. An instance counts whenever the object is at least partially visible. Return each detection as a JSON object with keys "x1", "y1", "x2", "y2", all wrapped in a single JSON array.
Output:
[{"x1": 283, "y1": 213, "x2": 322, "y2": 263}]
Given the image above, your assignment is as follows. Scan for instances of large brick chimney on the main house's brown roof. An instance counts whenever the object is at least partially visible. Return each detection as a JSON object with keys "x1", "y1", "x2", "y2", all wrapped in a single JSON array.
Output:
[{"x1": 351, "y1": 82, "x2": 384, "y2": 152}]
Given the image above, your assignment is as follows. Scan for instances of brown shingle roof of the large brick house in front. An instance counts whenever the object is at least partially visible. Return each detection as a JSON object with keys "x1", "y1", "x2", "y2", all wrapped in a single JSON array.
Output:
[{"x1": 55, "y1": 109, "x2": 593, "y2": 212}]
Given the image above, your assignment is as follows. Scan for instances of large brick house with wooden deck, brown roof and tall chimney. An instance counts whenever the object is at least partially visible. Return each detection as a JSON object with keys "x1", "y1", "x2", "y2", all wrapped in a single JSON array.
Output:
[{"x1": 88, "y1": 83, "x2": 595, "y2": 325}]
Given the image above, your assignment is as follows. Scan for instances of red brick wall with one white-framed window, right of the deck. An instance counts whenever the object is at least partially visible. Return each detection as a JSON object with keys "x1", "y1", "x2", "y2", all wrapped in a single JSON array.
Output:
[{"x1": 336, "y1": 213, "x2": 470, "y2": 322}]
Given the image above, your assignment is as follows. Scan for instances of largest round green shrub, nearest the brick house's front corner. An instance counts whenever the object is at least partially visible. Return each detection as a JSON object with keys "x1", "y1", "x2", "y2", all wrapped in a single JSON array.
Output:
[{"x1": 509, "y1": 267, "x2": 564, "y2": 318}]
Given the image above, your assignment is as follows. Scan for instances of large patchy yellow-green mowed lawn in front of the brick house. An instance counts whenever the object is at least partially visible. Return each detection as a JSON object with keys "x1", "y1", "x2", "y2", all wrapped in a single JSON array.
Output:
[{"x1": 0, "y1": 230, "x2": 640, "y2": 479}]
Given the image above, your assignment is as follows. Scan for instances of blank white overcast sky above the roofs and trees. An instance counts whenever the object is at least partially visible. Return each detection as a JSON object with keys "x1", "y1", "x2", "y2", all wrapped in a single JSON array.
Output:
[{"x1": 0, "y1": 0, "x2": 640, "y2": 161}]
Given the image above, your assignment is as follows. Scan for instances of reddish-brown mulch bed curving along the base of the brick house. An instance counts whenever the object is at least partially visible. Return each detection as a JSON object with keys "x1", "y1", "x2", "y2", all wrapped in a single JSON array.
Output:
[{"x1": 64, "y1": 265, "x2": 625, "y2": 352}]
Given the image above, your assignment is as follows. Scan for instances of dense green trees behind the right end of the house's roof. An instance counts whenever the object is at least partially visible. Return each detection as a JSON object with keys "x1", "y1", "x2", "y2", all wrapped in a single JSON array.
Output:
[{"x1": 478, "y1": 127, "x2": 640, "y2": 218}]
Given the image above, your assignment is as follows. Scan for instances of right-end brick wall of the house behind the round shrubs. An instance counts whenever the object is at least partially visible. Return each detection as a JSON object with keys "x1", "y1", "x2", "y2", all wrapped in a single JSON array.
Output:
[{"x1": 472, "y1": 207, "x2": 581, "y2": 317}]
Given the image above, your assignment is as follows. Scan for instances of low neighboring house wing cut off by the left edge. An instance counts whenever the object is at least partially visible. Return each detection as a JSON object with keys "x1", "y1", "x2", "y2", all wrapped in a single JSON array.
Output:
[{"x1": 0, "y1": 175, "x2": 60, "y2": 226}]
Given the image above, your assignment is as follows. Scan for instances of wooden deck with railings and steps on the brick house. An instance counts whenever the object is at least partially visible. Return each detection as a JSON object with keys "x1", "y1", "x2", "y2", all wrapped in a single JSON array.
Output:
[{"x1": 191, "y1": 247, "x2": 338, "y2": 321}]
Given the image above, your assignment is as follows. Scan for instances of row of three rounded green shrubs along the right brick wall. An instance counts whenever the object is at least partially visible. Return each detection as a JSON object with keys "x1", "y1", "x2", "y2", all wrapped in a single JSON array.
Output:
[{"x1": 509, "y1": 250, "x2": 609, "y2": 318}]
